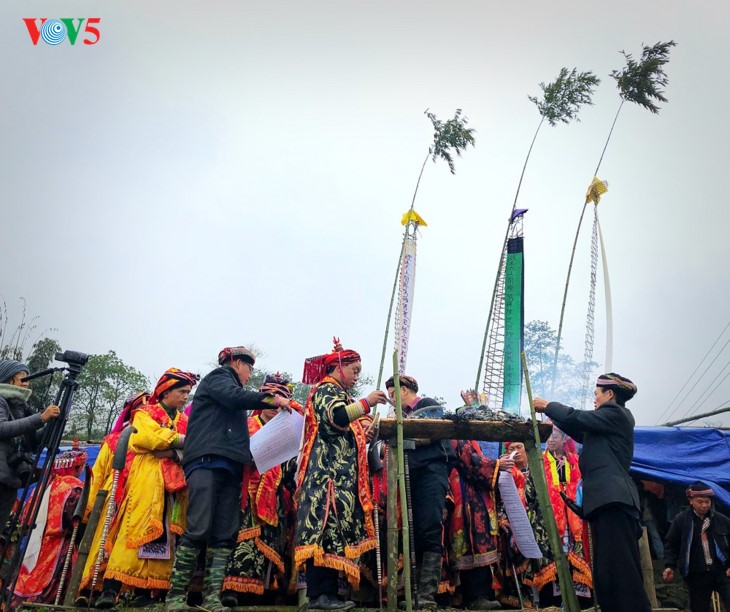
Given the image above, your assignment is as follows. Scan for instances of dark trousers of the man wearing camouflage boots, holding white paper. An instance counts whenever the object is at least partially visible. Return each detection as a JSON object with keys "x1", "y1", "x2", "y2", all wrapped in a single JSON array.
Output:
[{"x1": 180, "y1": 468, "x2": 241, "y2": 549}]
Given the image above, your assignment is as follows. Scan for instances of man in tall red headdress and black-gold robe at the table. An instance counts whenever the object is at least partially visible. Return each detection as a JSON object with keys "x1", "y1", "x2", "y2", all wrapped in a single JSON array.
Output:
[{"x1": 294, "y1": 339, "x2": 386, "y2": 610}]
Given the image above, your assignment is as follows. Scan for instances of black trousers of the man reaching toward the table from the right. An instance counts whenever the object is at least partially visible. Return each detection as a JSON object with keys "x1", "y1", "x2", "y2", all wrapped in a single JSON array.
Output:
[{"x1": 588, "y1": 504, "x2": 651, "y2": 612}]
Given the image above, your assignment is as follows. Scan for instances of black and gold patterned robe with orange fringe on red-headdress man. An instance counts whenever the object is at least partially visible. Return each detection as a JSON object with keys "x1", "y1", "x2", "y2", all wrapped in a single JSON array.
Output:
[{"x1": 294, "y1": 377, "x2": 376, "y2": 588}]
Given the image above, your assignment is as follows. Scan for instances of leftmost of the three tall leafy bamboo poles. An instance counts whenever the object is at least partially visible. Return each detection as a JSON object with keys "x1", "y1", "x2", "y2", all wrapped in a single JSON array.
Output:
[{"x1": 376, "y1": 108, "x2": 474, "y2": 388}]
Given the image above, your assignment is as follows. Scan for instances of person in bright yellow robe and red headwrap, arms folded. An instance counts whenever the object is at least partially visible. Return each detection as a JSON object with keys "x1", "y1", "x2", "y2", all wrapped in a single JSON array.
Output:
[{"x1": 96, "y1": 368, "x2": 197, "y2": 608}]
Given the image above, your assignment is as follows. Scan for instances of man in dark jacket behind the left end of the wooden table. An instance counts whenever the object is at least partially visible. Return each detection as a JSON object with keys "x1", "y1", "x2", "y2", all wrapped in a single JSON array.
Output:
[{"x1": 385, "y1": 375, "x2": 456, "y2": 609}]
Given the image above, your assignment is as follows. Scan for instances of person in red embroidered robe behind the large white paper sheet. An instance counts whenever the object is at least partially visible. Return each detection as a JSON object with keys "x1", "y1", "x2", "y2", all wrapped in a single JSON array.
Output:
[{"x1": 221, "y1": 374, "x2": 304, "y2": 608}]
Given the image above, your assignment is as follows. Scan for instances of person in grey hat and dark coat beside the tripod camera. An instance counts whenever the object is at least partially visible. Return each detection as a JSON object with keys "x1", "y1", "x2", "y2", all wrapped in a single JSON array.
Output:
[{"x1": 0, "y1": 359, "x2": 61, "y2": 530}]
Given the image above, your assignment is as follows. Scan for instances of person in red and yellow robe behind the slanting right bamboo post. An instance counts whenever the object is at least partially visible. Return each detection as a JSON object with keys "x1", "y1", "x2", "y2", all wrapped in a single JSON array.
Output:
[{"x1": 524, "y1": 426, "x2": 593, "y2": 607}]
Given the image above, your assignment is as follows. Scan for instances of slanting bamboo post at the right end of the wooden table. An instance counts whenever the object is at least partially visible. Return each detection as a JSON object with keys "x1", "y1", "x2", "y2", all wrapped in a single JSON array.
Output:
[{"x1": 522, "y1": 352, "x2": 580, "y2": 612}]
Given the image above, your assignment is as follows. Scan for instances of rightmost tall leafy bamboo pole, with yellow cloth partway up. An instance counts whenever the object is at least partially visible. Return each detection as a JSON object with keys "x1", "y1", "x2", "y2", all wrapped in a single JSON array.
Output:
[{"x1": 550, "y1": 40, "x2": 677, "y2": 394}]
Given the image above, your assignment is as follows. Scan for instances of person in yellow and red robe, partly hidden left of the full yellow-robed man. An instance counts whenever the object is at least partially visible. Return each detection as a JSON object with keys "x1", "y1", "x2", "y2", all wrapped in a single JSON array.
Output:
[{"x1": 76, "y1": 391, "x2": 150, "y2": 608}]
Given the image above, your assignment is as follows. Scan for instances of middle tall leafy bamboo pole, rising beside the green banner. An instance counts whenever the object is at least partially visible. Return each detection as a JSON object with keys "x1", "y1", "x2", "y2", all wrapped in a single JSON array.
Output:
[{"x1": 474, "y1": 68, "x2": 600, "y2": 389}]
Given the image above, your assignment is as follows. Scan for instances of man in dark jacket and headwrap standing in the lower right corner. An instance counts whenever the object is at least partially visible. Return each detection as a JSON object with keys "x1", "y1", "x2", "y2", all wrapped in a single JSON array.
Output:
[{"x1": 663, "y1": 482, "x2": 730, "y2": 612}]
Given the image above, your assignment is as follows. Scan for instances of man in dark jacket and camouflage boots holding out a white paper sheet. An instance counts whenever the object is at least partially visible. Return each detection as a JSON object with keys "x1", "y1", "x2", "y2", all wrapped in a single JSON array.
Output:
[{"x1": 166, "y1": 346, "x2": 289, "y2": 612}]
